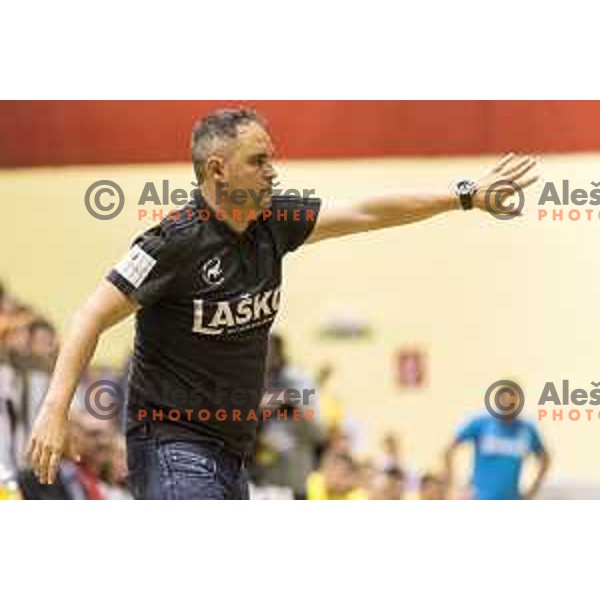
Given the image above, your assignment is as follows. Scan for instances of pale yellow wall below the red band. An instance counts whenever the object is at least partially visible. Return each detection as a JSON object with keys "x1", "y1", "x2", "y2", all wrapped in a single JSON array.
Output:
[{"x1": 0, "y1": 155, "x2": 600, "y2": 480}]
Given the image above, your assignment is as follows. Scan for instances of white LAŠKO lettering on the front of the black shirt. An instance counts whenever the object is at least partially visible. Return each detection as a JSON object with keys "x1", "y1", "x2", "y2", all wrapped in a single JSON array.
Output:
[{"x1": 192, "y1": 288, "x2": 281, "y2": 335}]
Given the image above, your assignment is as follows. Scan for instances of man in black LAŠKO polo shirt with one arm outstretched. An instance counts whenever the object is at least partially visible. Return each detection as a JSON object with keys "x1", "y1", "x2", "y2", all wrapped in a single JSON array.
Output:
[{"x1": 29, "y1": 109, "x2": 537, "y2": 499}]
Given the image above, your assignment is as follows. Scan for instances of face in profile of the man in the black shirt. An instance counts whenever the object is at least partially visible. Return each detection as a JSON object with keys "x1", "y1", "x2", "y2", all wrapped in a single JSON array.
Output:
[{"x1": 223, "y1": 123, "x2": 276, "y2": 212}]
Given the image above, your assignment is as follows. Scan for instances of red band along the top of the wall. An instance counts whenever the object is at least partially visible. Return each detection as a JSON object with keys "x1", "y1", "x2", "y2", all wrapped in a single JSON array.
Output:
[{"x1": 0, "y1": 100, "x2": 600, "y2": 167}]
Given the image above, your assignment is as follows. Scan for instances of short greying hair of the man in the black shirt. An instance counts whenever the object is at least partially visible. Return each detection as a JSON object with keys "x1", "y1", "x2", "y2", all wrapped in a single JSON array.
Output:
[{"x1": 192, "y1": 108, "x2": 264, "y2": 183}]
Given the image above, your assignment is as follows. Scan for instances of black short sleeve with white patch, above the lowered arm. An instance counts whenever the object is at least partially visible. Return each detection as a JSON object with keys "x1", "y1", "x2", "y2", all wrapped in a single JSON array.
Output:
[{"x1": 106, "y1": 226, "x2": 189, "y2": 306}]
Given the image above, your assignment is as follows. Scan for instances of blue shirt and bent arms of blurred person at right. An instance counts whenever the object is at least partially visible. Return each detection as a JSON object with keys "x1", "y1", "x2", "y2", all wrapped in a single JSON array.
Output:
[{"x1": 446, "y1": 404, "x2": 550, "y2": 500}]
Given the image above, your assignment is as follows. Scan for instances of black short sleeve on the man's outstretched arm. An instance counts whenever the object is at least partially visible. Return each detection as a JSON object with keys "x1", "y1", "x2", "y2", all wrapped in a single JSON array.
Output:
[{"x1": 265, "y1": 196, "x2": 321, "y2": 256}]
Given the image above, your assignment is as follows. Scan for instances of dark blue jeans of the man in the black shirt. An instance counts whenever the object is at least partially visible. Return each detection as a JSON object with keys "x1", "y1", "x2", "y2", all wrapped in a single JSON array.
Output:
[{"x1": 127, "y1": 435, "x2": 249, "y2": 500}]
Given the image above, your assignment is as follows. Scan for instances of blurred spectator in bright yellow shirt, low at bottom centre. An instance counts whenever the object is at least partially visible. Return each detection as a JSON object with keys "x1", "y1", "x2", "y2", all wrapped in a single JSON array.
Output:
[{"x1": 306, "y1": 452, "x2": 367, "y2": 500}]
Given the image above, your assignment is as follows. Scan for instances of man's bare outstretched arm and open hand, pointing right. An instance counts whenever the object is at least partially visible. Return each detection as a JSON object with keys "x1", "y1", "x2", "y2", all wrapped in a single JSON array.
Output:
[{"x1": 307, "y1": 154, "x2": 538, "y2": 243}]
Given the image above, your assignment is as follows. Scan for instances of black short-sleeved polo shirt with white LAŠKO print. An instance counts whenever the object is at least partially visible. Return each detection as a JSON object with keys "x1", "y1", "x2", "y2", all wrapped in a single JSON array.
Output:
[{"x1": 107, "y1": 194, "x2": 321, "y2": 453}]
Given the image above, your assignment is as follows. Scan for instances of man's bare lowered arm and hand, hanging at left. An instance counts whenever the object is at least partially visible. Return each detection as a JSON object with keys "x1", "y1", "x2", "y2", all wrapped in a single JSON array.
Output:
[{"x1": 27, "y1": 281, "x2": 139, "y2": 483}]
